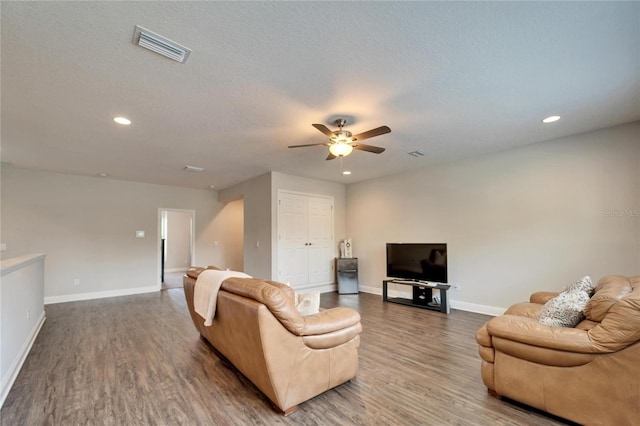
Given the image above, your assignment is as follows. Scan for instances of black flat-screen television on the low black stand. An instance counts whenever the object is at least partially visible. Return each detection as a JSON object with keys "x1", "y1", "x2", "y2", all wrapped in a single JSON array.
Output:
[{"x1": 387, "y1": 243, "x2": 447, "y2": 283}]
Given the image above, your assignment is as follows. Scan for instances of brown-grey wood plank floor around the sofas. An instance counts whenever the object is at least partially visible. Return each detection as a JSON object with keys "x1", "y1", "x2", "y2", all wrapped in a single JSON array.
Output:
[{"x1": 0, "y1": 289, "x2": 566, "y2": 426}]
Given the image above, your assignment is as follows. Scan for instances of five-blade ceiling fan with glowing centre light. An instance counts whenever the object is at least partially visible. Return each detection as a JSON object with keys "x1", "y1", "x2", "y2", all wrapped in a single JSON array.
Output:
[{"x1": 289, "y1": 118, "x2": 391, "y2": 160}]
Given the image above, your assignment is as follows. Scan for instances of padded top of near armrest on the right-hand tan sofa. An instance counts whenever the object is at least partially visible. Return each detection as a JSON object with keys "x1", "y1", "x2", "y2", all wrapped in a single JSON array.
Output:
[{"x1": 487, "y1": 315, "x2": 611, "y2": 354}]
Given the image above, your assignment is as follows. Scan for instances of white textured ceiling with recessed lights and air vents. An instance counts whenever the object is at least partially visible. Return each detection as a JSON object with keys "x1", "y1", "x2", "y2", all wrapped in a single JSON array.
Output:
[{"x1": 0, "y1": 1, "x2": 640, "y2": 189}]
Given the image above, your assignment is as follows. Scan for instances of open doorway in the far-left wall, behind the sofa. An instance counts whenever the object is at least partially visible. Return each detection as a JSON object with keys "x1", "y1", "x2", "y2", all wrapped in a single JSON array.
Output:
[{"x1": 158, "y1": 209, "x2": 196, "y2": 290}]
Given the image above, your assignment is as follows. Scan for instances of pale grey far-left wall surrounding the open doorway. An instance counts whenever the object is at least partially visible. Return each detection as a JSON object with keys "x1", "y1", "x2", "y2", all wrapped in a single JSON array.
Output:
[{"x1": 0, "y1": 166, "x2": 220, "y2": 303}]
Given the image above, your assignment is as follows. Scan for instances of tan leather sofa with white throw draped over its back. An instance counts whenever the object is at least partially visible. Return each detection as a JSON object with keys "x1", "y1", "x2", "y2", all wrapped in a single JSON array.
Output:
[{"x1": 184, "y1": 268, "x2": 362, "y2": 415}]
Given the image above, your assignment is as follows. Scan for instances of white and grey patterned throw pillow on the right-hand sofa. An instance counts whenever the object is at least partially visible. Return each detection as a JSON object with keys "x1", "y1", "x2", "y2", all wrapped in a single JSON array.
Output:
[{"x1": 538, "y1": 276, "x2": 593, "y2": 327}]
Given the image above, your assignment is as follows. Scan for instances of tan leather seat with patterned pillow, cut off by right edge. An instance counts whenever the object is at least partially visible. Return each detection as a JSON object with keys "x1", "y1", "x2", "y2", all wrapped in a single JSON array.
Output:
[{"x1": 476, "y1": 275, "x2": 640, "y2": 426}]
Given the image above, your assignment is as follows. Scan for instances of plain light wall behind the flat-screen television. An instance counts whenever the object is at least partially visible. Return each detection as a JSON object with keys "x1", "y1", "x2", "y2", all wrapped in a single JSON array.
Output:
[{"x1": 347, "y1": 123, "x2": 640, "y2": 312}]
